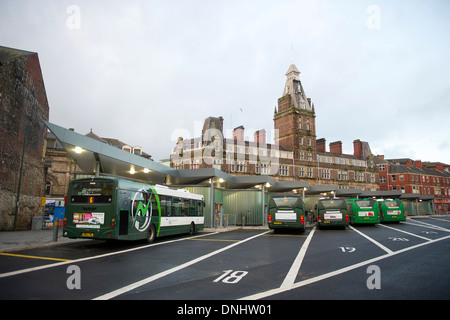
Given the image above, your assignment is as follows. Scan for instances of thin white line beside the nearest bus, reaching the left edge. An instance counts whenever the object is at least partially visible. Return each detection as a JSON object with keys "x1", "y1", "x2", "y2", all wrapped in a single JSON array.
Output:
[{"x1": 0, "y1": 232, "x2": 218, "y2": 278}]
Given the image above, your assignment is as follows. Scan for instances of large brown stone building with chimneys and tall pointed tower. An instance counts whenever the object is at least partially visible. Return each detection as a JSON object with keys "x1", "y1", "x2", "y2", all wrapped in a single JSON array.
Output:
[{"x1": 170, "y1": 64, "x2": 379, "y2": 191}]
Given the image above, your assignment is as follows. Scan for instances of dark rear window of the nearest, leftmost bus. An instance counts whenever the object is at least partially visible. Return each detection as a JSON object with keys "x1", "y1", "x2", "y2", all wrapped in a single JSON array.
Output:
[{"x1": 70, "y1": 180, "x2": 114, "y2": 204}]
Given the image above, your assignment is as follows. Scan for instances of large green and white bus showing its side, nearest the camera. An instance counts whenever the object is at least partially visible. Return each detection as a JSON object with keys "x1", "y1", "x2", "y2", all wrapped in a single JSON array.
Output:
[{"x1": 63, "y1": 177, "x2": 205, "y2": 243}]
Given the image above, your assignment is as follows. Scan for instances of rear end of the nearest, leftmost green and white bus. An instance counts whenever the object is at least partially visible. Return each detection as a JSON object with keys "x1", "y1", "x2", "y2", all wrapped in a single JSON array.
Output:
[{"x1": 63, "y1": 178, "x2": 117, "y2": 239}]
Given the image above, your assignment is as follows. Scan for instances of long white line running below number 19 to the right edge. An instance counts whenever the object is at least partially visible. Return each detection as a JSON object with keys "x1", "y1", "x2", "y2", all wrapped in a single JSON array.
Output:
[{"x1": 239, "y1": 231, "x2": 450, "y2": 300}]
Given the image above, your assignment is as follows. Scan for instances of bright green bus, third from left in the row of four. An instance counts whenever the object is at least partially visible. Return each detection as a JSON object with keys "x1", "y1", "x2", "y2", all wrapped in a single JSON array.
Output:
[{"x1": 347, "y1": 199, "x2": 380, "y2": 224}]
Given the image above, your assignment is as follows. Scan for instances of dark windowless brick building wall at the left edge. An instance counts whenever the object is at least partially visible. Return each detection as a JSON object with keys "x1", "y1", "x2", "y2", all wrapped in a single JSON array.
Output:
[{"x1": 0, "y1": 47, "x2": 49, "y2": 230}]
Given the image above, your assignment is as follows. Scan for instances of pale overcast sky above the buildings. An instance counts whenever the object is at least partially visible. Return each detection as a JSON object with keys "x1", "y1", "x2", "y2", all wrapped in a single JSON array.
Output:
[{"x1": 0, "y1": 0, "x2": 450, "y2": 163}]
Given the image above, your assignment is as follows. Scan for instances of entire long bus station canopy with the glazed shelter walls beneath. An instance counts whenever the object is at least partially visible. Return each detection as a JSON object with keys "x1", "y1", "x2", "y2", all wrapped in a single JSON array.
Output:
[{"x1": 45, "y1": 122, "x2": 434, "y2": 228}]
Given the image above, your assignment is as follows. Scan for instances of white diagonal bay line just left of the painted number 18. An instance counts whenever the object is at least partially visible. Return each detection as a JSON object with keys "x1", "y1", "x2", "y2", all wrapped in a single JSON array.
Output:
[{"x1": 93, "y1": 231, "x2": 270, "y2": 300}]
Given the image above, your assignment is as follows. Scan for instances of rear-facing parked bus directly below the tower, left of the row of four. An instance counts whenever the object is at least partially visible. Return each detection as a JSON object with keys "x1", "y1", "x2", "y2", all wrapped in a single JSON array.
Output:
[{"x1": 268, "y1": 196, "x2": 305, "y2": 231}]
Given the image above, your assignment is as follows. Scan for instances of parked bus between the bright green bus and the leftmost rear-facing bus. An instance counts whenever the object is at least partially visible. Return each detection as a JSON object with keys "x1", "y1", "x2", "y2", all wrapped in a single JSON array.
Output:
[{"x1": 316, "y1": 198, "x2": 348, "y2": 229}]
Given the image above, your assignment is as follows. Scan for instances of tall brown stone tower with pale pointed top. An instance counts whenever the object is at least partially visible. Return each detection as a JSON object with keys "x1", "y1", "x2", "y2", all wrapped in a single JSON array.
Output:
[{"x1": 274, "y1": 63, "x2": 316, "y2": 161}]
